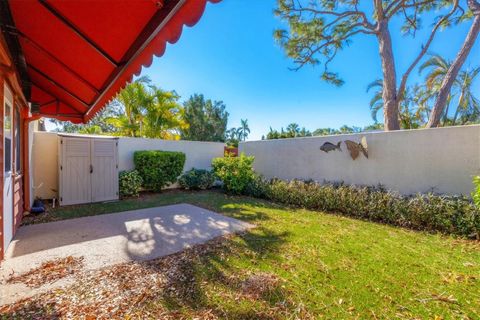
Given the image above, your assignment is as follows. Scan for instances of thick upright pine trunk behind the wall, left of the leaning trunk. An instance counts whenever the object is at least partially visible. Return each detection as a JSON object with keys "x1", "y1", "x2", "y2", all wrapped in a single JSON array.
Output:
[{"x1": 377, "y1": 20, "x2": 400, "y2": 131}]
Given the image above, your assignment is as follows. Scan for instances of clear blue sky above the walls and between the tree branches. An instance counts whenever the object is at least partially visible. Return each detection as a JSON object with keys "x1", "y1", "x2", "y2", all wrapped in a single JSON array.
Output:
[{"x1": 142, "y1": 0, "x2": 480, "y2": 140}]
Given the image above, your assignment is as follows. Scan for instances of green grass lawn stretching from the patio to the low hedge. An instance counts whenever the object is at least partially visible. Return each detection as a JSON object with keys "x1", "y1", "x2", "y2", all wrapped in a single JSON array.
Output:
[{"x1": 13, "y1": 191, "x2": 480, "y2": 319}]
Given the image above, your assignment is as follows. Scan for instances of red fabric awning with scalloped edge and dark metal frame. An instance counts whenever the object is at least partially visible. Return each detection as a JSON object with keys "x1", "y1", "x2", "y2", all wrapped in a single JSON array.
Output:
[{"x1": 10, "y1": 0, "x2": 220, "y2": 123}]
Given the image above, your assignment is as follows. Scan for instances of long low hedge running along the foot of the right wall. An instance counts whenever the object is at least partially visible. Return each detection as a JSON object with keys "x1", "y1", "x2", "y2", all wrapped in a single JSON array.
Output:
[{"x1": 244, "y1": 177, "x2": 480, "y2": 238}]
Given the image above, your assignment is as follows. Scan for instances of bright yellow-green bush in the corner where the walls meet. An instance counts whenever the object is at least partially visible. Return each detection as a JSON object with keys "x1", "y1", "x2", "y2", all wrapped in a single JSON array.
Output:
[{"x1": 212, "y1": 154, "x2": 255, "y2": 194}]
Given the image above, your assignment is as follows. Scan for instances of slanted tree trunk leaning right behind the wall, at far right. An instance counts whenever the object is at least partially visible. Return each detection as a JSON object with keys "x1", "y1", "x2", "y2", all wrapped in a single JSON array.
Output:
[{"x1": 427, "y1": 12, "x2": 480, "y2": 128}]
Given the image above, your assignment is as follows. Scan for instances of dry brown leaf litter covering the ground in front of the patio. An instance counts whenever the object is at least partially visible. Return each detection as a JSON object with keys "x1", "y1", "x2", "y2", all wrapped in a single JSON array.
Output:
[{"x1": 0, "y1": 239, "x2": 229, "y2": 319}]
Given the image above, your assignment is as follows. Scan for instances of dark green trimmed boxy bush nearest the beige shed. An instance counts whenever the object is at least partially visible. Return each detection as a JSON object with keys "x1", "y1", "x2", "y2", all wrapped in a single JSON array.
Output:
[{"x1": 133, "y1": 150, "x2": 185, "y2": 191}]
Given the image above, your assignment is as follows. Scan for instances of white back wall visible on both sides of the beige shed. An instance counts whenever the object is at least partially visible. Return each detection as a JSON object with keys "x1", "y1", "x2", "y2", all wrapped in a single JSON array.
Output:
[{"x1": 31, "y1": 132, "x2": 224, "y2": 199}]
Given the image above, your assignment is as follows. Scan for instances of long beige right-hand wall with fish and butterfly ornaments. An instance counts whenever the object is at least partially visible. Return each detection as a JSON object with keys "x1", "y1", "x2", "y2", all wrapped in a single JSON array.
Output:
[{"x1": 239, "y1": 125, "x2": 480, "y2": 195}]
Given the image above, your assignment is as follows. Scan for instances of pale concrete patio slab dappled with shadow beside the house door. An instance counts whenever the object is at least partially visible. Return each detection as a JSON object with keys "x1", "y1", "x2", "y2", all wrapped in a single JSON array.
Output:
[{"x1": 0, "y1": 204, "x2": 253, "y2": 305}]
